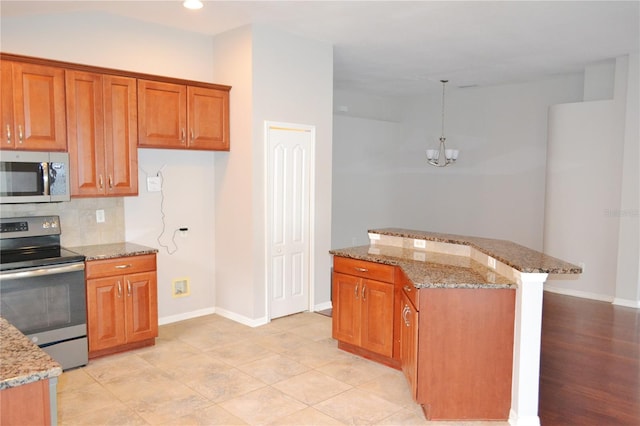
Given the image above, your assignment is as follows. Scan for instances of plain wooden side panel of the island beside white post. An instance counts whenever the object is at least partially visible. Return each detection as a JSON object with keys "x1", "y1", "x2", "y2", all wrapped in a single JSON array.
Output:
[{"x1": 416, "y1": 288, "x2": 515, "y2": 420}]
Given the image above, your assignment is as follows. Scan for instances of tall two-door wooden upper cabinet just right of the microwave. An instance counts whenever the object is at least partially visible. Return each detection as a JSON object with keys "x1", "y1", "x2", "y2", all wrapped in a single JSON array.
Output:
[{"x1": 66, "y1": 71, "x2": 138, "y2": 197}]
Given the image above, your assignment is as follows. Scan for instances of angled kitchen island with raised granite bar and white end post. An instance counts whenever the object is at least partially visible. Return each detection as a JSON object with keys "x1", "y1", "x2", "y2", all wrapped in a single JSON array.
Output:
[{"x1": 331, "y1": 228, "x2": 581, "y2": 425}]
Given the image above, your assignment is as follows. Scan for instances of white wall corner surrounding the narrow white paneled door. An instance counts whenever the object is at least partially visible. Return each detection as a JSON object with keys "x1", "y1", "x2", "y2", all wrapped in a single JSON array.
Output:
[{"x1": 214, "y1": 26, "x2": 333, "y2": 324}]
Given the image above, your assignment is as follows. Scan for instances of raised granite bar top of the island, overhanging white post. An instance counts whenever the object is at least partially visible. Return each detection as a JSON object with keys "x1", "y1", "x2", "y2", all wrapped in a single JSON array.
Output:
[{"x1": 369, "y1": 228, "x2": 582, "y2": 274}]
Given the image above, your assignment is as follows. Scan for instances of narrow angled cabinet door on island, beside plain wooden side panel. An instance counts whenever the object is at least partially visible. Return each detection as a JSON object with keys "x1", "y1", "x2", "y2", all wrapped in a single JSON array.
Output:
[{"x1": 400, "y1": 293, "x2": 419, "y2": 400}]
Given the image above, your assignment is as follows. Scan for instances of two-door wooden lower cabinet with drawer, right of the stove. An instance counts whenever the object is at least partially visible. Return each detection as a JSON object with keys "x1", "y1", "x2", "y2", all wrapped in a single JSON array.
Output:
[{"x1": 86, "y1": 254, "x2": 158, "y2": 358}]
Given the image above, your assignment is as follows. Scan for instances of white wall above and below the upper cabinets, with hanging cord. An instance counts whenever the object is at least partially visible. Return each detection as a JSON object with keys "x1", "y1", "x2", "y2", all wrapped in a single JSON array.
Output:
[{"x1": 0, "y1": 13, "x2": 220, "y2": 322}]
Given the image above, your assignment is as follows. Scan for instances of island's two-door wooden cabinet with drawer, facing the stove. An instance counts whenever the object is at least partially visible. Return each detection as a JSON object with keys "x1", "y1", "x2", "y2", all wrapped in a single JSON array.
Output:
[{"x1": 332, "y1": 258, "x2": 394, "y2": 359}]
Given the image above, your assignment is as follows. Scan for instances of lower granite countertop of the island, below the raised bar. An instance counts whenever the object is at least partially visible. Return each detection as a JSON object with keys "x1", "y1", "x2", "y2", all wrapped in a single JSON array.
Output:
[{"x1": 330, "y1": 245, "x2": 516, "y2": 289}]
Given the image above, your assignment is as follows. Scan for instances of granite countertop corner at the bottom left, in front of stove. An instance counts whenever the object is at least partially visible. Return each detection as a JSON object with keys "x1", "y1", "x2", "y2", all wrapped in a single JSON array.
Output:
[{"x1": 0, "y1": 317, "x2": 62, "y2": 390}]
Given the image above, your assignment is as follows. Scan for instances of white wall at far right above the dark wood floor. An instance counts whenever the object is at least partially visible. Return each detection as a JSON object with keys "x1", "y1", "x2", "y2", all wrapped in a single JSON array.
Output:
[{"x1": 544, "y1": 54, "x2": 640, "y2": 307}]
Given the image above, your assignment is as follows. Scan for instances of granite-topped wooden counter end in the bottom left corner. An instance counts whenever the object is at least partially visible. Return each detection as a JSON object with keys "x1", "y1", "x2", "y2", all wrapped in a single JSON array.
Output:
[{"x1": 0, "y1": 317, "x2": 62, "y2": 426}]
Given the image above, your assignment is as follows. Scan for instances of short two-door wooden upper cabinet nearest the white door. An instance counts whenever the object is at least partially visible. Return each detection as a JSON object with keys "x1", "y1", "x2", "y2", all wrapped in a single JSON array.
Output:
[{"x1": 138, "y1": 79, "x2": 229, "y2": 151}]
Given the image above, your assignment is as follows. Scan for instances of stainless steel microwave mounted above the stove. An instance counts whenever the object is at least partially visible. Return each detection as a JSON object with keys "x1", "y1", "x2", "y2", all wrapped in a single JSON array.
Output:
[{"x1": 0, "y1": 150, "x2": 71, "y2": 204}]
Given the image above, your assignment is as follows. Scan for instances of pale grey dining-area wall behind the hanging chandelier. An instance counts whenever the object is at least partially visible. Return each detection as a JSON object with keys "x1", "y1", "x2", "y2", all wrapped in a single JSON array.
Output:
[{"x1": 332, "y1": 75, "x2": 582, "y2": 250}]
